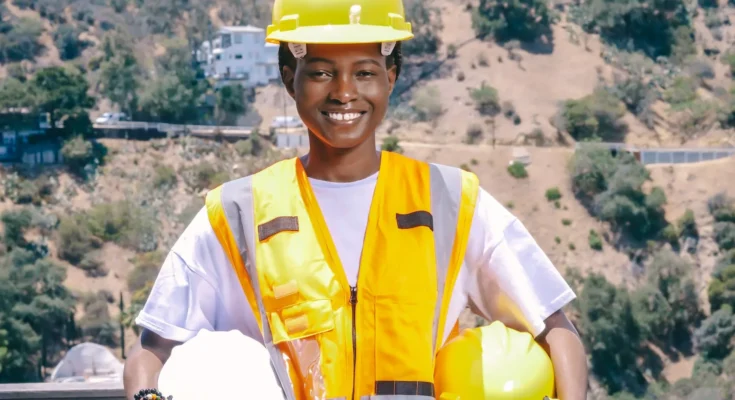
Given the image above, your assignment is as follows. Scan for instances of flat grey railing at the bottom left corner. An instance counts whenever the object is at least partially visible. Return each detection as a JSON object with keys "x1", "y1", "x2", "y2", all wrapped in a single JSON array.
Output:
[{"x1": 0, "y1": 382, "x2": 125, "y2": 400}]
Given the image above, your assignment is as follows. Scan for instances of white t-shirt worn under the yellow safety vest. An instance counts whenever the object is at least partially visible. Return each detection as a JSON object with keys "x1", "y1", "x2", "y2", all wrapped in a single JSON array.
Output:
[{"x1": 136, "y1": 174, "x2": 575, "y2": 342}]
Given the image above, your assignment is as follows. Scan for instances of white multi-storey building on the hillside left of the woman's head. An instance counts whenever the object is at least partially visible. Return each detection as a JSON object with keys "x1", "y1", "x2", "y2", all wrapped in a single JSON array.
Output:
[{"x1": 197, "y1": 25, "x2": 280, "y2": 87}]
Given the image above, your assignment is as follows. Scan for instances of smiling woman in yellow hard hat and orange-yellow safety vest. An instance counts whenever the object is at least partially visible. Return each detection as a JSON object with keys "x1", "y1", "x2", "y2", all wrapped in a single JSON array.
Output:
[{"x1": 125, "y1": 0, "x2": 587, "y2": 400}]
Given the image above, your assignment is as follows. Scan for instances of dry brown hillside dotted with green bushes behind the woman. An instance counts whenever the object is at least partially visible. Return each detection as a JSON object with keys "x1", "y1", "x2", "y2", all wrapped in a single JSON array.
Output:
[{"x1": 0, "y1": 0, "x2": 735, "y2": 400}]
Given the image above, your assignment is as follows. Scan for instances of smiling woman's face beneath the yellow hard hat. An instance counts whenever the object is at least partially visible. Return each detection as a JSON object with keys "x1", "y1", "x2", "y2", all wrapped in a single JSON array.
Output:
[{"x1": 283, "y1": 44, "x2": 396, "y2": 149}]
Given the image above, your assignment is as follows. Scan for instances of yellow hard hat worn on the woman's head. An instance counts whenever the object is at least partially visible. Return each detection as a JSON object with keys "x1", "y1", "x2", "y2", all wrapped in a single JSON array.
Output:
[{"x1": 265, "y1": 0, "x2": 413, "y2": 44}]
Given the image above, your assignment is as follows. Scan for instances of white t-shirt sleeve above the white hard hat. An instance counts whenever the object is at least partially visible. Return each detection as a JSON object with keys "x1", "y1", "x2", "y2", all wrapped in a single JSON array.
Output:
[{"x1": 135, "y1": 208, "x2": 221, "y2": 342}]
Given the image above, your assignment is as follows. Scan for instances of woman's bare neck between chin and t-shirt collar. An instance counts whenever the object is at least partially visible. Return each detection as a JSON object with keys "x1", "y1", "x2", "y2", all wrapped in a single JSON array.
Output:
[{"x1": 302, "y1": 133, "x2": 380, "y2": 182}]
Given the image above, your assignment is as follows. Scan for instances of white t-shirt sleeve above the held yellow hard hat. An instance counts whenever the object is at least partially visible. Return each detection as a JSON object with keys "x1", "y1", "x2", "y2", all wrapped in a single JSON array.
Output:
[{"x1": 465, "y1": 189, "x2": 576, "y2": 337}]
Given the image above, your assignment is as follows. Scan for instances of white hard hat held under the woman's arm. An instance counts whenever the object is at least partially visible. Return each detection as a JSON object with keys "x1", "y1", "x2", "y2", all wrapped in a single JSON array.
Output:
[{"x1": 158, "y1": 330, "x2": 284, "y2": 400}]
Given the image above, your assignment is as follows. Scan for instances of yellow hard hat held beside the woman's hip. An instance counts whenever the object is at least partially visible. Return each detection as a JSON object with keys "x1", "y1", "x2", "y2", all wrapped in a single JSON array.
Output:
[{"x1": 434, "y1": 321, "x2": 554, "y2": 400}]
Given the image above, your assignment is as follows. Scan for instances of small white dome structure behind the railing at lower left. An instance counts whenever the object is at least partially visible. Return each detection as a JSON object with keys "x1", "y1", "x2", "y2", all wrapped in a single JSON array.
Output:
[{"x1": 50, "y1": 343, "x2": 123, "y2": 382}]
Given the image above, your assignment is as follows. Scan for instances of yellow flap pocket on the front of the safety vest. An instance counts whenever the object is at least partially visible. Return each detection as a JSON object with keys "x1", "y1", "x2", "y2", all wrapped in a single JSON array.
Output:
[{"x1": 268, "y1": 299, "x2": 335, "y2": 344}]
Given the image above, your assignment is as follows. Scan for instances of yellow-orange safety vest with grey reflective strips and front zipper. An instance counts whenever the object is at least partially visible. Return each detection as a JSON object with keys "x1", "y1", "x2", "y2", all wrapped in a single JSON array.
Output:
[{"x1": 206, "y1": 152, "x2": 479, "y2": 400}]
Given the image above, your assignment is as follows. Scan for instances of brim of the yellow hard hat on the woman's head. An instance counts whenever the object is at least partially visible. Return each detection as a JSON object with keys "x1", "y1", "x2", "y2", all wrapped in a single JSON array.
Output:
[{"x1": 265, "y1": 25, "x2": 414, "y2": 44}]
